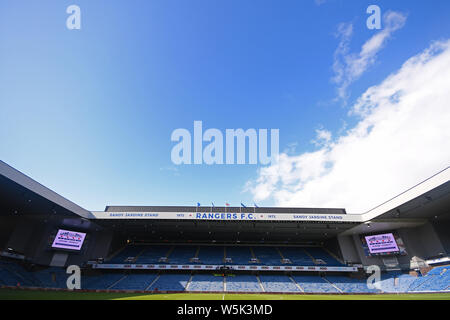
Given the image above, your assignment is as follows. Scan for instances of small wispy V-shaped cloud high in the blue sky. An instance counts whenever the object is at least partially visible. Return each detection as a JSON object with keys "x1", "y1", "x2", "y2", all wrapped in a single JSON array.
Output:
[{"x1": 332, "y1": 11, "x2": 406, "y2": 100}]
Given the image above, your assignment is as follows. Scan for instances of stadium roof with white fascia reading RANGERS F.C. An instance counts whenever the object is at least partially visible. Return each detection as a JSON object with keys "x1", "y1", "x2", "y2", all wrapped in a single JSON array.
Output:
[{"x1": 0, "y1": 161, "x2": 450, "y2": 239}]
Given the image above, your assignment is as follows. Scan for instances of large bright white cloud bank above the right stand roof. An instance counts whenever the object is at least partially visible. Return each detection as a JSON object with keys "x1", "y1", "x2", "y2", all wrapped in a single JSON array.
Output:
[{"x1": 246, "y1": 40, "x2": 450, "y2": 213}]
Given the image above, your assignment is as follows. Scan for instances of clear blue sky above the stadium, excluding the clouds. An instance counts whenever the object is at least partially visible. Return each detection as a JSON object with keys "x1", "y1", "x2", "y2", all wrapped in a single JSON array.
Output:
[{"x1": 0, "y1": 0, "x2": 450, "y2": 210}]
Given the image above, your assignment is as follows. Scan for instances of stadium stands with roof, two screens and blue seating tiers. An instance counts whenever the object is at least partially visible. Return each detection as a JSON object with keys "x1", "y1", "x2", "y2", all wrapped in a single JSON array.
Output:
[{"x1": 0, "y1": 161, "x2": 450, "y2": 293}]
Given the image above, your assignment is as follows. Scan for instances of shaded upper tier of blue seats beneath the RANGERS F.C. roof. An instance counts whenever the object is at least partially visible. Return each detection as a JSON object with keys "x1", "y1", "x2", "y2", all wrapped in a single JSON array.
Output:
[{"x1": 108, "y1": 245, "x2": 343, "y2": 266}]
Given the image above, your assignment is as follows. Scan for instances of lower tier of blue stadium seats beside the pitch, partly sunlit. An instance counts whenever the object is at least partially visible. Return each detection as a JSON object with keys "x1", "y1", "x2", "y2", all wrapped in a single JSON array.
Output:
[{"x1": 0, "y1": 260, "x2": 450, "y2": 293}]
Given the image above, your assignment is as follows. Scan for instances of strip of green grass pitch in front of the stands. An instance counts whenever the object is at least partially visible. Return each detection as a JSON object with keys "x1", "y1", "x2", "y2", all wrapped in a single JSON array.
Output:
[{"x1": 0, "y1": 289, "x2": 450, "y2": 300}]
